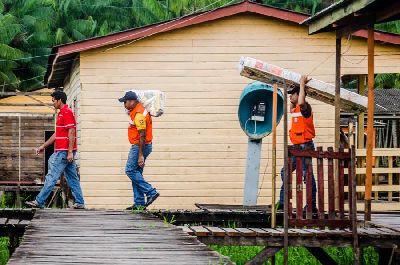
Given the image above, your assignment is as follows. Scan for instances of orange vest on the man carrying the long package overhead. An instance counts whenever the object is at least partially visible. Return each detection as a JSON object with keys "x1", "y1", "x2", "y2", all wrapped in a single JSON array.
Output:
[{"x1": 289, "y1": 105, "x2": 315, "y2": 144}]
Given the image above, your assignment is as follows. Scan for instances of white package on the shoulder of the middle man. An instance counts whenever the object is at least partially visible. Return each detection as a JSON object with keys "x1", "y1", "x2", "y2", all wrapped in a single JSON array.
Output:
[{"x1": 129, "y1": 89, "x2": 165, "y2": 117}]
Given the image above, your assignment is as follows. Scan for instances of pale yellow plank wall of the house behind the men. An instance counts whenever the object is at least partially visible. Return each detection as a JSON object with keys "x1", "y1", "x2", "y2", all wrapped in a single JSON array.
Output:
[{"x1": 64, "y1": 15, "x2": 400, "y2": 209}]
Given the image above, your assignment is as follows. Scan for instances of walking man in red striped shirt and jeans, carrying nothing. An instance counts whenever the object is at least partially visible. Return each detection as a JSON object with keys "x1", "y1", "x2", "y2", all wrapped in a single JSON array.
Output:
[{"x1": 25, "y1": 91, "x2": 85, "y2": 209}]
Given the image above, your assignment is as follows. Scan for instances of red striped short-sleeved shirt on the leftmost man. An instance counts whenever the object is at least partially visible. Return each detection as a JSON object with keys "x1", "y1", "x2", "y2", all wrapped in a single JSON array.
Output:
[{"x1": 55, "y1": 104, "x2": 77, "y2": 151}]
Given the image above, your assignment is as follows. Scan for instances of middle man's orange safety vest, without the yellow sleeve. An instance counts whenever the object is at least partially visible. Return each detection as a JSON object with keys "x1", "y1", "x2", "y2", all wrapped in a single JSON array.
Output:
[{"x1": 128, "y1": 103, "x2": 153, "y2": 144}]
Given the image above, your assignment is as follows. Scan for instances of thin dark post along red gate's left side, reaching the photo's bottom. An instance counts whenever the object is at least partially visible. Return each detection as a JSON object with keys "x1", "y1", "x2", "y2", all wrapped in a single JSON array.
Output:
[{"x1": 283, "y1": 82, "x2": 291, "y2": 265}]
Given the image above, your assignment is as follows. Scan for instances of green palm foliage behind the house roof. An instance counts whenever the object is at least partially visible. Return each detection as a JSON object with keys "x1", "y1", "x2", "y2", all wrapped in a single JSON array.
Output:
[{"x1": 0, "y1": 0, "x2": 400, "y2": 91}]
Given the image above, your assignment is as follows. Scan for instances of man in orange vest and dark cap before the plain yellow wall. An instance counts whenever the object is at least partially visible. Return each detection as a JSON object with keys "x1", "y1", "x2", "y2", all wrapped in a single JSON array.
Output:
[{"x1": 119, "y1": 91, "x2": 160, "y2": 210}]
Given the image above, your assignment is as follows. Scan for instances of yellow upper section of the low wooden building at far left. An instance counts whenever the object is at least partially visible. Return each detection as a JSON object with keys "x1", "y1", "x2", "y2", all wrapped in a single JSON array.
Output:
[{"x1": 0, "y1": 88, "x2": 55, "y2": 114}]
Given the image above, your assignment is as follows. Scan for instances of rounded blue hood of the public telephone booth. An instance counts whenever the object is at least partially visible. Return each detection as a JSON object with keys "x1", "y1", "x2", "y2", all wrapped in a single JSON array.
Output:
[{"x1": 238, "y1": 81, "x2": 283, "y2": 140}]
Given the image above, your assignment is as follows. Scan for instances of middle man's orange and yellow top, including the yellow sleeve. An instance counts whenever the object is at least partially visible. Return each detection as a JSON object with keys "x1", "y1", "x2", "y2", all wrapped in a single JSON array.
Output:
[{"x1": 128, "y1": 103, "x2": 153, "y2": 144}]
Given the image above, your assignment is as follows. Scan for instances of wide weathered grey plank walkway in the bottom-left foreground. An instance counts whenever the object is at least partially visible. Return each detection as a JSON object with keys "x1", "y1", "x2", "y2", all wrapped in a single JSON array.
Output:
[{"x1": 8, "y1": 209, "x2": 233, "y2": 265}]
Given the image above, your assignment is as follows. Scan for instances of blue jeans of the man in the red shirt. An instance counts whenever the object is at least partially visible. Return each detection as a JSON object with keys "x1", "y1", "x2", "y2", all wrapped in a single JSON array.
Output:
[{"x1": 36, "y1": 151, "x2": 85, "y2": 207}]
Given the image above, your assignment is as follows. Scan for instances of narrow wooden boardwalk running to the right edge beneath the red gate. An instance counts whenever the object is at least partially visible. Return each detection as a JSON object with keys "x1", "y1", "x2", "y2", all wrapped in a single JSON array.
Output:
[{"x1": 181, "y1": 226, "x2": 400, "y2": 248}]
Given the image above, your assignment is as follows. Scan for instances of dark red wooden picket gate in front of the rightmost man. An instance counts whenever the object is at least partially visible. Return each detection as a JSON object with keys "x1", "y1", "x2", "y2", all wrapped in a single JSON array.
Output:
[{"x1": 288, "y1": 147, "x2": 356, "y2": 228}]
